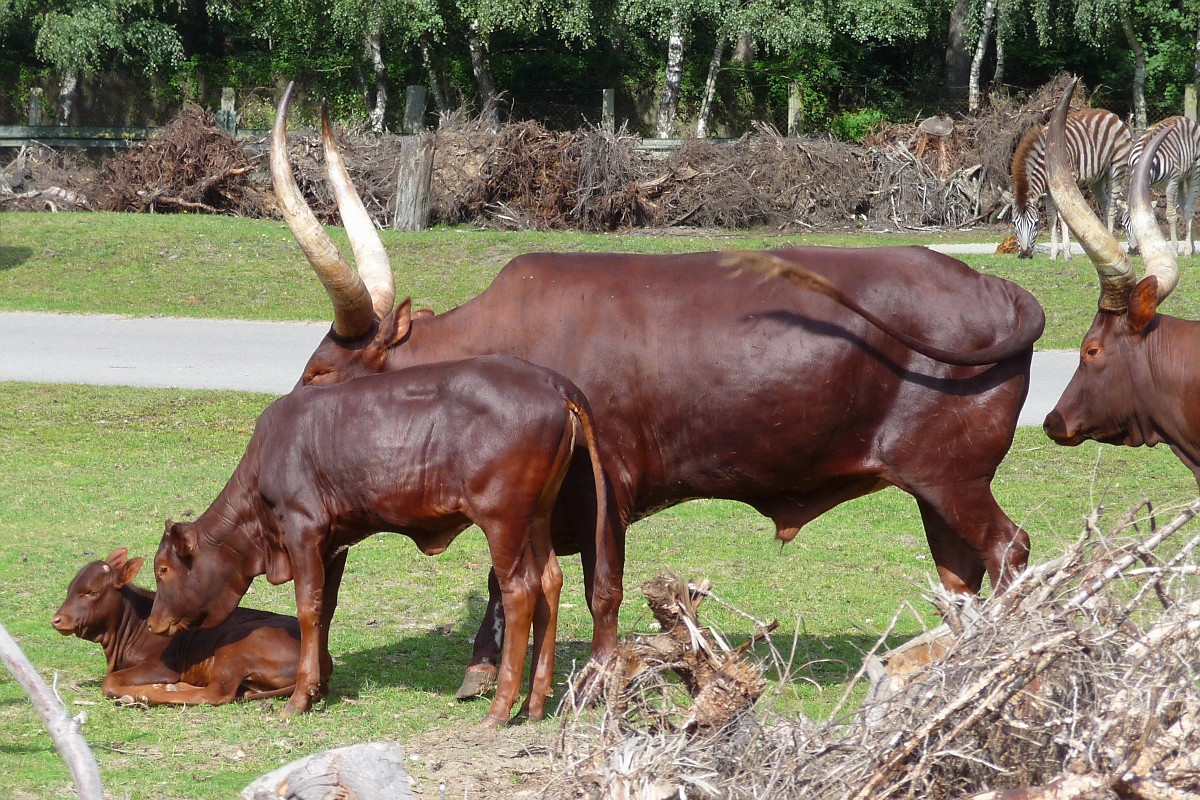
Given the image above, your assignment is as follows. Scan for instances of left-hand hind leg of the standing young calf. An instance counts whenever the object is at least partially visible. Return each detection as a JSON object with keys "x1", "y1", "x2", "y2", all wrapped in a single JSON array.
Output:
[{"x1": 479, "y1": 522, "x2": 541, "y2": 727}]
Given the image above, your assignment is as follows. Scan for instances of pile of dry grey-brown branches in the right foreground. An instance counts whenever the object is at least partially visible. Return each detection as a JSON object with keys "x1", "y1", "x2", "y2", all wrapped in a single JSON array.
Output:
[{"x1": 546, "y1": 500, "x2": 1200, "y2": 800}]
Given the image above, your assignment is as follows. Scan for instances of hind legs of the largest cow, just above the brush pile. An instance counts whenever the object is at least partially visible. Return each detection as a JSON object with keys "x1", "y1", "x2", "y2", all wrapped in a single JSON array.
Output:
[{"x1": 913, "y1": 480, "x2": 1030, "y2": 594}]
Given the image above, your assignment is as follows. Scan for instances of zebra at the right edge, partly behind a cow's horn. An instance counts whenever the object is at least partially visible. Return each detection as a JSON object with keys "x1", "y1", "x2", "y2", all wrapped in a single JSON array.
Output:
[{"x1": 1129, "y1": 116, "x2": 1200, "y2": 255}]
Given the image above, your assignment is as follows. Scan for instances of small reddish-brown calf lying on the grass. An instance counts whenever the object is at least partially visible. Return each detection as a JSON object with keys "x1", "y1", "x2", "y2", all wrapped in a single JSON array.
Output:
[{"x1": 50, "y1": 547, "x2": 300, "y2": 705}]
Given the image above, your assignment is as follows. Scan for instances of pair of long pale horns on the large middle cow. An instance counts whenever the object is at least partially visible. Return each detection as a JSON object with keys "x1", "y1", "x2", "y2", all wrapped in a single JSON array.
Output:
[{"x1": 271, "y1": 83, "x2": 396, "y2": 338}]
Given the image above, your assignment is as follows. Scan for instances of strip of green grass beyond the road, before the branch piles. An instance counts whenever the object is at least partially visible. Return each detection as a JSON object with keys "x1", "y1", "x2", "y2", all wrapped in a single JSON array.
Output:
[{"x1": 0, "y1": 213, "x2": 1200, "y2": 349}]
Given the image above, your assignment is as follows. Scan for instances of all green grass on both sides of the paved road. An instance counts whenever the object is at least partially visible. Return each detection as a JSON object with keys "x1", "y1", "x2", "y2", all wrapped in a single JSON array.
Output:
[{"x1": 0, "y1": 213, "x2": 1200, "y2": 800}]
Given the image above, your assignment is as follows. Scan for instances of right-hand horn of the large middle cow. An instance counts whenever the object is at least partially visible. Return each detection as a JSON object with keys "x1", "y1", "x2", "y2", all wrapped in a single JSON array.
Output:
[{"x1": 320, "y1": 103, "x2": 396, "y2": 319}]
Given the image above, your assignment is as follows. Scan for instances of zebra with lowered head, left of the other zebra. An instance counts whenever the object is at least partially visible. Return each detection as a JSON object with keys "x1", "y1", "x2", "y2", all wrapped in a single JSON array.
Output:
[{"x1": 1013, "y1": 108, "x2": 1133, "y2": 261}]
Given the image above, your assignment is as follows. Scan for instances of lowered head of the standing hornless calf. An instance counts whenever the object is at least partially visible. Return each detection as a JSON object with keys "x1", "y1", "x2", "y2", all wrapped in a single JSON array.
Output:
[{"x1": 148, "y1": 519, "x2": 255, "y2": 636}]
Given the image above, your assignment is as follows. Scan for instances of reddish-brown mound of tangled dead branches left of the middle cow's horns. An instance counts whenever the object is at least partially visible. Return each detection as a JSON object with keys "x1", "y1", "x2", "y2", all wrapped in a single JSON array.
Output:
[{"x1": 100, "y1": 103, "x2": 272, "y2": 216}]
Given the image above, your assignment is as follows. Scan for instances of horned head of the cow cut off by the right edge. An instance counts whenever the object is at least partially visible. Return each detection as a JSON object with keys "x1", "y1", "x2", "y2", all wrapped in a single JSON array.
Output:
[{"x1": 1043, "y1": 84, "x2": 1180, "y2": 446}]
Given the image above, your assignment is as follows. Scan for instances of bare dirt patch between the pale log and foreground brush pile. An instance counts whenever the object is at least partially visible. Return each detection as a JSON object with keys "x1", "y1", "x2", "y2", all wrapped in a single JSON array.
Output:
[{"x1": 404, "y1": 722, "x2": 558, "y2": 800}]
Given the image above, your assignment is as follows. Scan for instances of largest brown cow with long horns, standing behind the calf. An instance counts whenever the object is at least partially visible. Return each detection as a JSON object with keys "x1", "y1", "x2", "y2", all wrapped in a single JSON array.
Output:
[{"x1": 271, "y1": 86, "x2": 1045, "y2": 696}]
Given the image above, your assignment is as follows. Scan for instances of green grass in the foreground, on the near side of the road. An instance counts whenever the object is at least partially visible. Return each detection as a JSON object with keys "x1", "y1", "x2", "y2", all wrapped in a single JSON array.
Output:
[{"x1": 0, "y1": 384, "x2": 1196, "y2": 800}]
